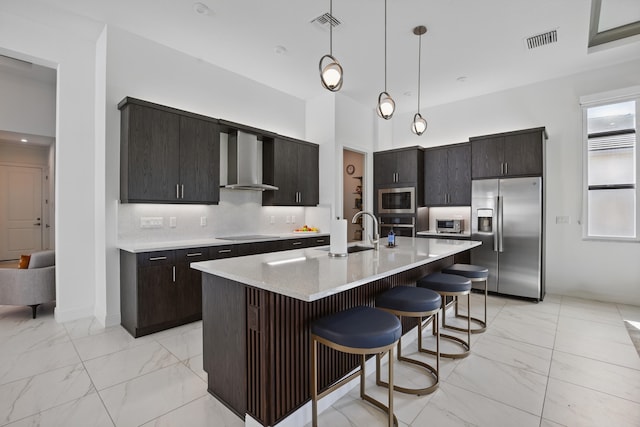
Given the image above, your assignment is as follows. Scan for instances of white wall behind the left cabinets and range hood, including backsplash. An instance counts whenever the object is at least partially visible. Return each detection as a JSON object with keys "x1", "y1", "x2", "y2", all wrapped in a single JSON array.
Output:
[{"x1": 104, "y1": 27, "x2": 315, "y2": 322}]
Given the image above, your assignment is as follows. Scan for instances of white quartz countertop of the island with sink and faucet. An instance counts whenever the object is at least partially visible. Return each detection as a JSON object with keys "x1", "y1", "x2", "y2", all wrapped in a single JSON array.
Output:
[{"x1": 191, "y1": 236, "x2": 481, "y2": 301}]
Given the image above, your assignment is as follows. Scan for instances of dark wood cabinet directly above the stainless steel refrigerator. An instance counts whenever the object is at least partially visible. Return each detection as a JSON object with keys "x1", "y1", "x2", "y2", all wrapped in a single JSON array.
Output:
[{"x1": 469, "y1": 128, "x2": 546, "y2": 179}]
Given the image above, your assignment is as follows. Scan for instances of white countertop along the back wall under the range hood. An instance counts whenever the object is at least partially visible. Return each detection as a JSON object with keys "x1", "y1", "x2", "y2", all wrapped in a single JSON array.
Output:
[{"x1": 118, "y1": 232, "x2": 329, "y2": 253}]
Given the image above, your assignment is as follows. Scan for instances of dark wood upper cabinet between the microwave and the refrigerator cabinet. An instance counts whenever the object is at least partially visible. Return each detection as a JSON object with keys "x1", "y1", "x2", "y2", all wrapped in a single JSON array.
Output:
[{"x1": 424, "y1": 143, "x2": 471, "y2": 206}]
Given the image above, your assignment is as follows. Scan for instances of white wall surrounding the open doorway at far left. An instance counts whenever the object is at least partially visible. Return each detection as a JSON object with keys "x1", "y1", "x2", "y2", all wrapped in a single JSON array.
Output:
[{"x1": 0, "y1": 2, "x2": 96, "y2": 321}]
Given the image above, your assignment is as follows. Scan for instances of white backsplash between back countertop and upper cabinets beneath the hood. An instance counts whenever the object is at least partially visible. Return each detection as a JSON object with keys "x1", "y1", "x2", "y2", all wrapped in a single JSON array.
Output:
[{"x1": 117, "y1": 189, "x2": 330, "y2": 242}]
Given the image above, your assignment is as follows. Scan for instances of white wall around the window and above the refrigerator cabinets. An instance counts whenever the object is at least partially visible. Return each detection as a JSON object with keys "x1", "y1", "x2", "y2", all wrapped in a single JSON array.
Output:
[{"x1": 392, "y1": 60, "x2": 640, "y2": 304}]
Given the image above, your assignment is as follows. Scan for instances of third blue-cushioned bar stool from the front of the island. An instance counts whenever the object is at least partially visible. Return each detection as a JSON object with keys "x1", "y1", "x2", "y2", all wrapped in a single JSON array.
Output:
[{"x1": 416, "y1": 273, "x2": 471, "y2": 359}]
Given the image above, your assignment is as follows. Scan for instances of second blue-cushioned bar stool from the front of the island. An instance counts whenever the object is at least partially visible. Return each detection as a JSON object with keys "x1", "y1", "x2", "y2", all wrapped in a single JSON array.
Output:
[{"x1": 376, "y1": 286, "x2": 442, "y2": 396}]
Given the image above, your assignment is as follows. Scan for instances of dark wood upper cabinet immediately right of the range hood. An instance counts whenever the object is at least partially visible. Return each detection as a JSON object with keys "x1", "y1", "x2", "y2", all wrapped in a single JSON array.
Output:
[{"x1": 262, "y1": 137, "x2": 320, "y2": 206}]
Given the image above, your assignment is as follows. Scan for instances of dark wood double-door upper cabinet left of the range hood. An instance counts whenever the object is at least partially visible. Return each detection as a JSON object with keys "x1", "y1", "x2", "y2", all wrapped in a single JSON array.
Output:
[{"x1": 118, "y1": 98, "x2": 220, "y2": 204}]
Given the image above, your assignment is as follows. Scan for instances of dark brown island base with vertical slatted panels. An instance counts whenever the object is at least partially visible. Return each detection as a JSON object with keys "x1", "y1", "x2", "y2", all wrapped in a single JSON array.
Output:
[{"x1": 202, "y1": 256, "x2": 456, "y2": 426}]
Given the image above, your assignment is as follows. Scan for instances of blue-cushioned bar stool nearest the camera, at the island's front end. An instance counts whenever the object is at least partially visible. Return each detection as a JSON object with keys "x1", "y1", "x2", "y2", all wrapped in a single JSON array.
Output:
[{"x1": 311, "y1": 306, "x2": 402, "y2": 427}]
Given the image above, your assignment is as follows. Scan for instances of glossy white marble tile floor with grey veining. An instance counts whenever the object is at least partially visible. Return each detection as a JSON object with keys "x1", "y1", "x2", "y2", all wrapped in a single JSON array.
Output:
[{"x1": 0, "y1": 294, "x2": 640, "y2": 427}]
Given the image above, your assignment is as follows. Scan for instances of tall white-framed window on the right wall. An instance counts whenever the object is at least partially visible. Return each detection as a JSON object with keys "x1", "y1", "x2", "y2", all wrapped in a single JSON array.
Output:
[{"x1": 583, "y1": 87, "x2": 640, "y2": 240}]
